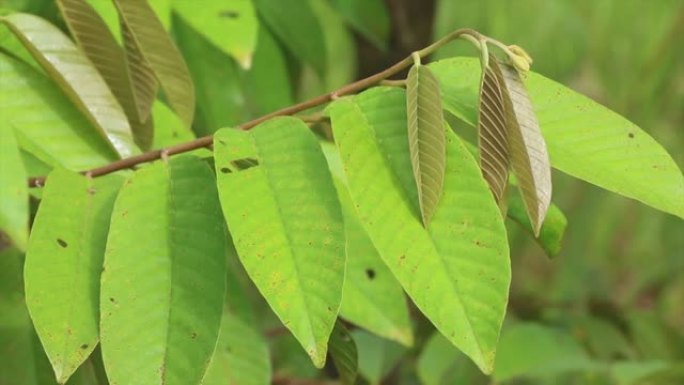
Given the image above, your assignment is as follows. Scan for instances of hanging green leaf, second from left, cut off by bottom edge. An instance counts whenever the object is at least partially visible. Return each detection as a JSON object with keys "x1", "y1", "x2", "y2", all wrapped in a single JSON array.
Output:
[{"x1": 100, "y1": 157, "x2": 226, "y2": 385}]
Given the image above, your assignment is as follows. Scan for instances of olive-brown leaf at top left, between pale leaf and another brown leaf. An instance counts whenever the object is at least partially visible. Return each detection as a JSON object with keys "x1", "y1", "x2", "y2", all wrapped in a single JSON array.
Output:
[{"x1": 57, "y1": 0, "x2": 153, "y2": 149}]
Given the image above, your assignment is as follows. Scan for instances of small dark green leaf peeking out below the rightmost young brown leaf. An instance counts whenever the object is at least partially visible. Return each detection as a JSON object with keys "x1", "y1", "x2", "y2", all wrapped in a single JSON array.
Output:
[{"x1": 508, "y1": 188, "x2": 568, "y2": 257}]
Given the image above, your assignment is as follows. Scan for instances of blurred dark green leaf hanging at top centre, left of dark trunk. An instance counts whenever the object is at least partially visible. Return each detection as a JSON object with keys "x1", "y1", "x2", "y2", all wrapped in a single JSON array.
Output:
[{"x1": 254, "y1": 0, "x2": 327, "y2": 76}]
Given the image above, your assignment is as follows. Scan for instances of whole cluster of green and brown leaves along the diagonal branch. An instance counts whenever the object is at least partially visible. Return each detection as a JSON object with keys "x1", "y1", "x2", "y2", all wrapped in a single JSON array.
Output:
[{"x1": 0, "y1": 0, "x2": 684, "y2": 384}]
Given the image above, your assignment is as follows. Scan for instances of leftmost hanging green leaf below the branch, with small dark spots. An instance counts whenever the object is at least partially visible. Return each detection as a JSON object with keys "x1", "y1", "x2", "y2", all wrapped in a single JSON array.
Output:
[{"x1": 24, "y1": 168, "x2": 122, "y2": 384}]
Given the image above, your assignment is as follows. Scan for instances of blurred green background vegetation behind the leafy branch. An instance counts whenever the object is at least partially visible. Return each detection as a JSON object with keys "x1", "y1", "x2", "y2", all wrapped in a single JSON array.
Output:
[{"x1": 0, "y1": 0, "x2": 684, "y2": 385}]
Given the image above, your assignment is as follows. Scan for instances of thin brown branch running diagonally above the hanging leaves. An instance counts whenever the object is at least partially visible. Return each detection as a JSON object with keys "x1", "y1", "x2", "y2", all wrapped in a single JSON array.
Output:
[{"x1": 28, "y1": 28, "x2": 482, "y2": 187}]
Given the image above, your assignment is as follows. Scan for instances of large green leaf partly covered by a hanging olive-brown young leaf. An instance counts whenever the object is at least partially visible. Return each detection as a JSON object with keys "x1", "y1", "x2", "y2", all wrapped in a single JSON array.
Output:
[{"x1": 329, "y1": 88, "x2": 510, "y2": 372}]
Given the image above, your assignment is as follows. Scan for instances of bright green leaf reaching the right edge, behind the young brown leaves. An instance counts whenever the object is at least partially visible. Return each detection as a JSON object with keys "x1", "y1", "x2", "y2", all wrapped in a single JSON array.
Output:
[{"x1": 430, "y1": 58, "x2": 684, "y2": 218}]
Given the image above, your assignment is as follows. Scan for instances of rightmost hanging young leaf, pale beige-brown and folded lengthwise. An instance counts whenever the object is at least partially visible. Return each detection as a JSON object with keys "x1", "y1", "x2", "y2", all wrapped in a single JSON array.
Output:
[{"x1": 500, "y1": 64, "x2": 551, "y2": 236}]
